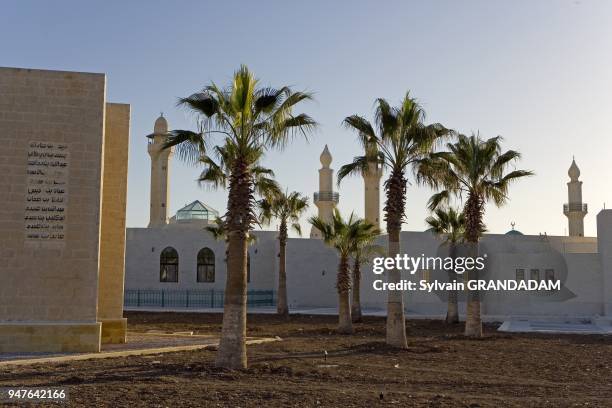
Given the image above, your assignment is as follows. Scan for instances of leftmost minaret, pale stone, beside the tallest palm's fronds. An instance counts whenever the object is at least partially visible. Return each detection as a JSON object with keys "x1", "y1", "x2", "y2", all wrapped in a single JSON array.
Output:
[{"x1": 147, "y1": 114, "x2": 174, "y2": 228}]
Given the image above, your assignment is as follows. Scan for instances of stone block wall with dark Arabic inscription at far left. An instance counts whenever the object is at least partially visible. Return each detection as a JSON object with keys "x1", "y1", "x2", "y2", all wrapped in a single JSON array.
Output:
[{"x1": 0, "y1": 68, "x2": 106, "y2": 352}]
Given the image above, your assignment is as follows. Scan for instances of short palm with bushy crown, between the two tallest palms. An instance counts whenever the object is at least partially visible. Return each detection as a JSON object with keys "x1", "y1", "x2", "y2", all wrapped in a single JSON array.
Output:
[{"x1": 308, "y1": 209, "x2": 379, "y2": 334}]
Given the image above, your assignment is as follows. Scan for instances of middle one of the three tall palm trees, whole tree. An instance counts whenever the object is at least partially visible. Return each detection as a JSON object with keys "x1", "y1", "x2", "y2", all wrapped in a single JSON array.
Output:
[{"x1": 338, "y1": 93, "x2": 451, "y2": 348}]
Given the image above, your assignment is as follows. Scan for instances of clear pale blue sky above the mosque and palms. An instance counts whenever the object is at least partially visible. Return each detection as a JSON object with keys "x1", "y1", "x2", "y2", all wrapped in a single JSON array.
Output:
[{"x1": 0, "y1": 0, "x2": 612, "y2": 235}]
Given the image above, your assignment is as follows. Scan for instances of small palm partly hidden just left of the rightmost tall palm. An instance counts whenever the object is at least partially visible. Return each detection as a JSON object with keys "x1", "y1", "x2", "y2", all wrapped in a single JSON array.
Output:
[{"x1": 425, "y1": 207, "x2": 465, "y2": 324}]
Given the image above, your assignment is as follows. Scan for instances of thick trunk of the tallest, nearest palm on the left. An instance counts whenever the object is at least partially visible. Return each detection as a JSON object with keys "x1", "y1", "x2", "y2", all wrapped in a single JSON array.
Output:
[{"x1": 215, "y1": 159, "x2": 253, "y2": 369}]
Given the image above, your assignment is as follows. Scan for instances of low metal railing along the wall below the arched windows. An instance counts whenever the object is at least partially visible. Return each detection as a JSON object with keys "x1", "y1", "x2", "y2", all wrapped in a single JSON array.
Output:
[{"x1": 123, "y1": 289, "x2": 276, "y2": 308}]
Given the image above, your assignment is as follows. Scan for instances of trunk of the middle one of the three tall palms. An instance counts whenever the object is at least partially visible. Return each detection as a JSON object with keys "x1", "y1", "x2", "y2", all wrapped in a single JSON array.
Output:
[{"x1": 385, "y1": 170, "x2": 408, "y2": 348}]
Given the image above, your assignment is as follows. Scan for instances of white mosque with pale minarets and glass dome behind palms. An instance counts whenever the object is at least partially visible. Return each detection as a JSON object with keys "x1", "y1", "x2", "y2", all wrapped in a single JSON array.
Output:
[{"x1": 125, "y1": 116, "x2": 612, "y2": 325}]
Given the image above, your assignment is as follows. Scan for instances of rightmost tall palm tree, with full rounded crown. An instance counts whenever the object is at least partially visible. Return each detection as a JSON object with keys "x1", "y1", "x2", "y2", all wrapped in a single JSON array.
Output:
[{"x1": 417, "y1": 134, "x2": 533, "y2": 337}]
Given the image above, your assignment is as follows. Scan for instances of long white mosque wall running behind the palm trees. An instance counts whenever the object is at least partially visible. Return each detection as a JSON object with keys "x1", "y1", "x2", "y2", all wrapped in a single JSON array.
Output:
[{"x1": 126, "y1": 217, "x2": 612, "y2": 319}]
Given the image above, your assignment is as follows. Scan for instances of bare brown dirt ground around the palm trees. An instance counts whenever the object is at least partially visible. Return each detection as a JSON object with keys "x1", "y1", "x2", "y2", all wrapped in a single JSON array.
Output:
[{"x1": 0, "y1": 312, "x2": 612, "y2": 408}]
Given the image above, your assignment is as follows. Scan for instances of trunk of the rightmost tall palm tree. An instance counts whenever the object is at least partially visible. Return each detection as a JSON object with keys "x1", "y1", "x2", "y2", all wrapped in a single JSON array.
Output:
[{"x1": 465, "y1": 194, "x2": 484, "y2": 337}]
